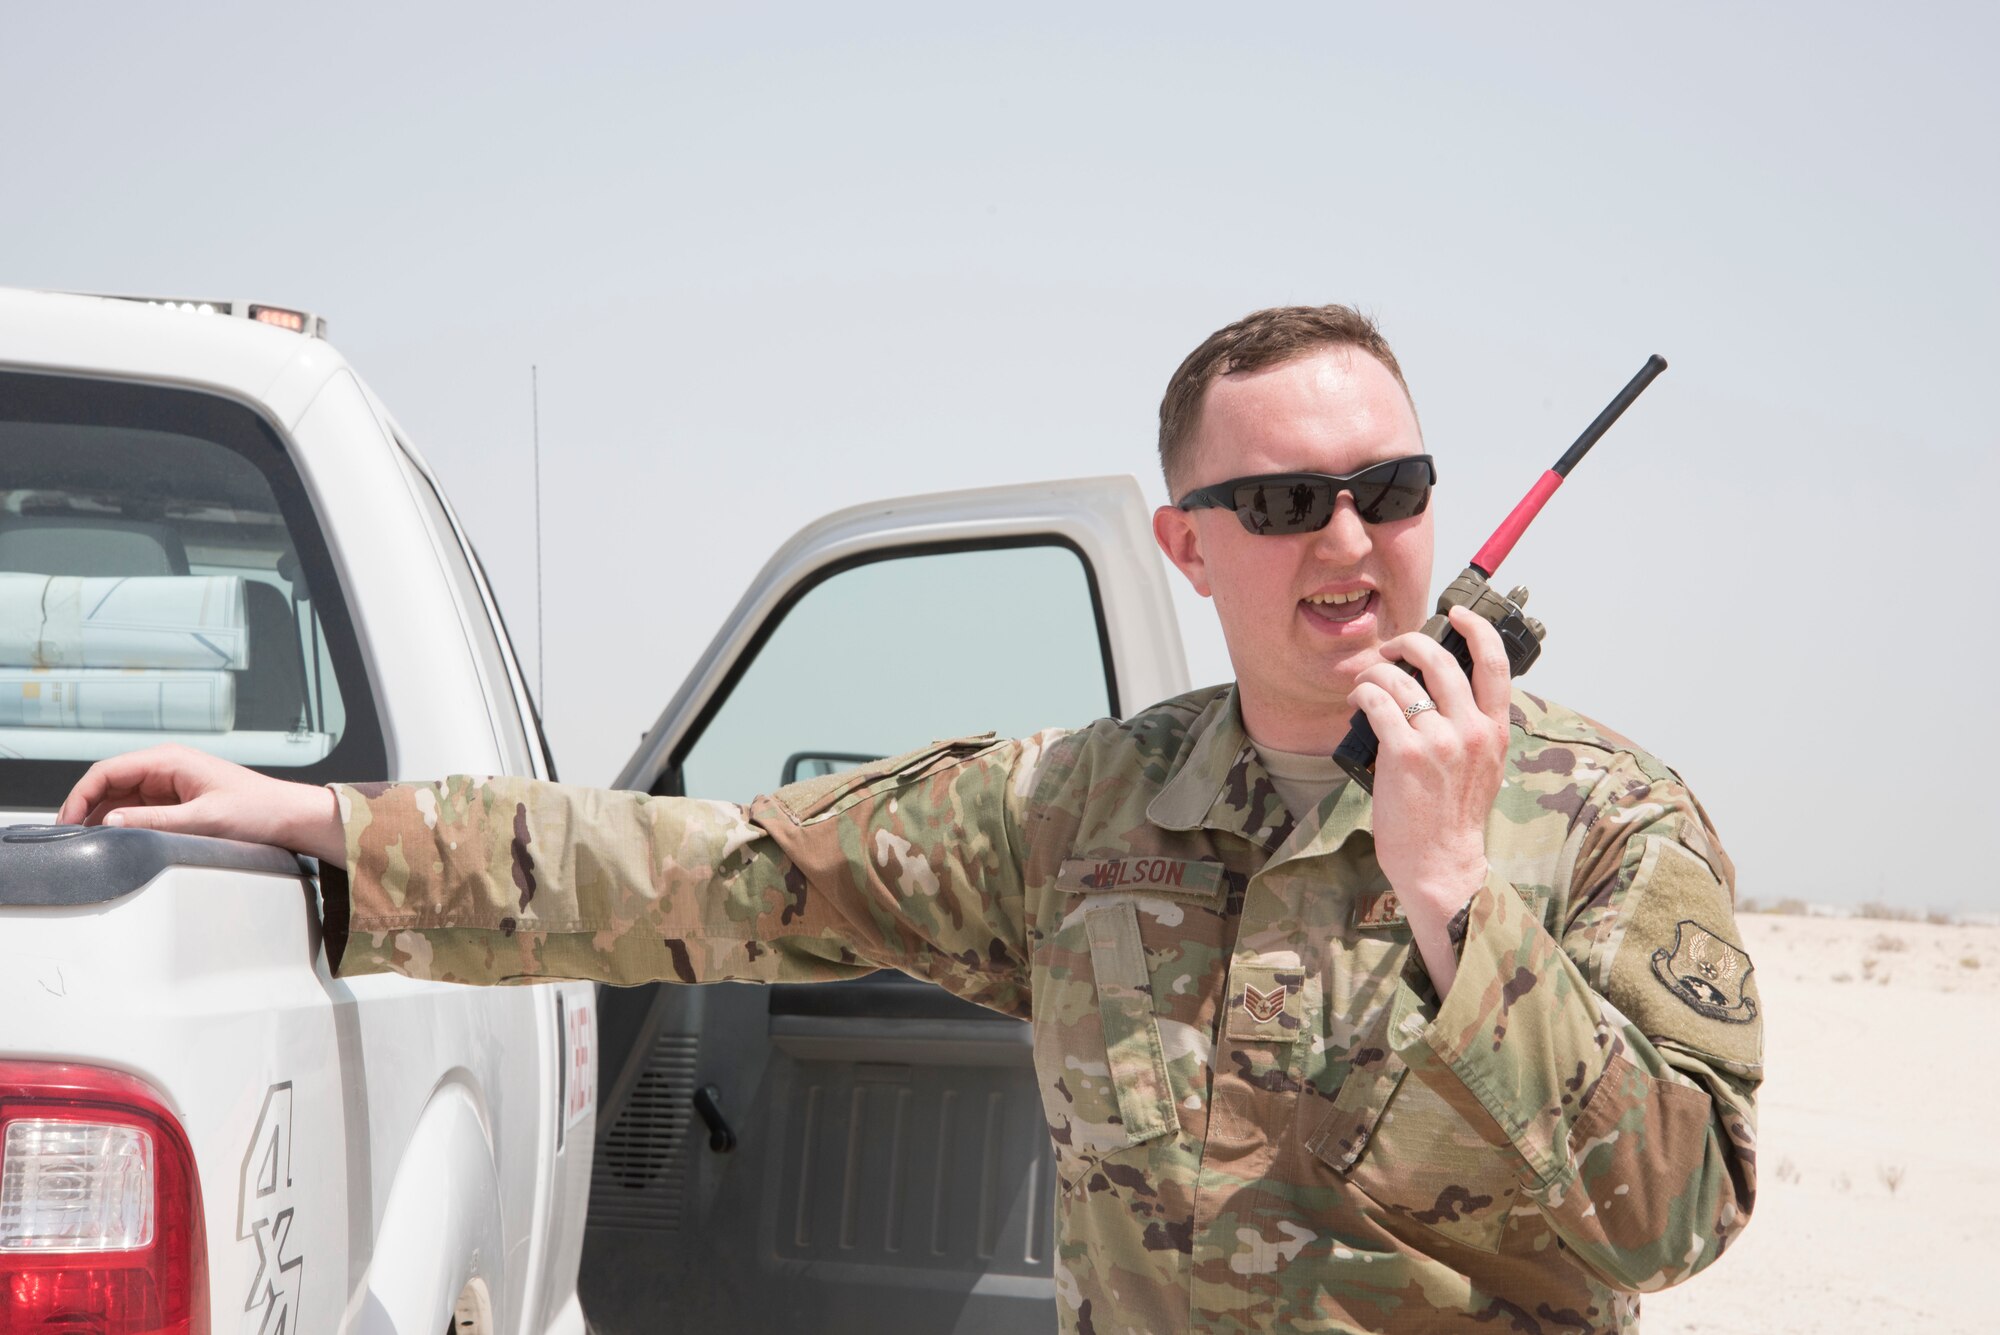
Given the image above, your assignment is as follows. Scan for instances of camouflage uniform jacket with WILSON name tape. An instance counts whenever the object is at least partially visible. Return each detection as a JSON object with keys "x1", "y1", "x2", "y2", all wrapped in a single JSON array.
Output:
[{"x1": 328, "y1": 687, "x2": 1762, "y2": 1335}]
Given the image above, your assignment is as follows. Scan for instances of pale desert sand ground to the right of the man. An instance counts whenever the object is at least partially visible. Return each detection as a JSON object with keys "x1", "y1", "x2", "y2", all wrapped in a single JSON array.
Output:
[{"x1": 1640, "y1": 913, "x2": 2000, "y2": 1335}]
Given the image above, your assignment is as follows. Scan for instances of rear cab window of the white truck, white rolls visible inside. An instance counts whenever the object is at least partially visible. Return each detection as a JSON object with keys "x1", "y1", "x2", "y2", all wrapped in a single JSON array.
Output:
[{"x1": 0, "y1": 372, "x2": 386, "y2": 809}]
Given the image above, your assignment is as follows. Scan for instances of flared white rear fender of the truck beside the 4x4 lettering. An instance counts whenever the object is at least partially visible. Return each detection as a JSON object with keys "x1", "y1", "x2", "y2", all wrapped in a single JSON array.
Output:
[{"x1": 348, "y1": 1079, "x2": 506, "y2": 1335}]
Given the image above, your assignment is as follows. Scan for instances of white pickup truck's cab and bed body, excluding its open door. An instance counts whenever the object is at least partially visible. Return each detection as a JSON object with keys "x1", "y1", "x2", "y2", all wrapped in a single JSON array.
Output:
[{"x1": 0, "y1": 292, "x2": 596, "y2": 1335}]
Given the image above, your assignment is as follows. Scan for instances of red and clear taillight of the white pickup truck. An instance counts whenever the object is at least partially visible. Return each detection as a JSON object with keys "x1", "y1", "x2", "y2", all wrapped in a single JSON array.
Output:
[{"x1": 0, "y1": 1061, "x2": 208, "y2": 1335}]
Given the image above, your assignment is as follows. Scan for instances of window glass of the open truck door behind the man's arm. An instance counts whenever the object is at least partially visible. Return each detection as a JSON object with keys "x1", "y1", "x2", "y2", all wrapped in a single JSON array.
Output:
[{"x1": 666, "y1": 538, "x2": 1118, "y2": 801}]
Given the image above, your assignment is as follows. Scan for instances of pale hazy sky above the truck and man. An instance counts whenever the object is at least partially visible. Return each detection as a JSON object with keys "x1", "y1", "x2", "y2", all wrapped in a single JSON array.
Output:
[{"x1": 0, "y1": 4, "x2": 2000, "y2": 911}]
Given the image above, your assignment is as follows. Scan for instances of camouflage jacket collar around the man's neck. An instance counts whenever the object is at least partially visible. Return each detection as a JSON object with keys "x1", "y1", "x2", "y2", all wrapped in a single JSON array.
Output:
[{"x1": 1146, "y1": 685, "x2": 1374, "y2": 853}]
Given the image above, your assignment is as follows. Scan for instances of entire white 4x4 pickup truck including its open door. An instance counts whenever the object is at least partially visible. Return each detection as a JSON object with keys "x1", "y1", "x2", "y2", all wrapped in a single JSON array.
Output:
[{"x1": 0, "y1": 292, "x2": 1188, "y2": 1335}]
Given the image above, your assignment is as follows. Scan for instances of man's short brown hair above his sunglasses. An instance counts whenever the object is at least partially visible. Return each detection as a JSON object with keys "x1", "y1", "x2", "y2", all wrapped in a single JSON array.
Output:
[{"x1": 1160, "y1": 306, "x2": 1416, "y2": 500}]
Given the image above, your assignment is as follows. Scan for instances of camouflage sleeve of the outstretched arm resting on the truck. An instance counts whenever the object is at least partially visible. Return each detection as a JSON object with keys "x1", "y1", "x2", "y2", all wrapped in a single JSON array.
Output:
[{"x1": 326, "y1": 735, "x2": 1048, "y2": 1015}]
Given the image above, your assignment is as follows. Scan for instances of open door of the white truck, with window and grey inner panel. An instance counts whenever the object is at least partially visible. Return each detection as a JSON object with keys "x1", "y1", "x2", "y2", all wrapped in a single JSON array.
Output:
[{"x1": 578, "y1": 478, "x2": 1188, "y2": 1335}]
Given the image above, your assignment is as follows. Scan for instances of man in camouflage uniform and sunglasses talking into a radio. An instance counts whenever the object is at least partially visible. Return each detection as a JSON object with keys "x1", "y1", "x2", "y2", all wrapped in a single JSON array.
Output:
[{"x1": 62, "y1": 308, "x2": 1762, "y2": 1335}]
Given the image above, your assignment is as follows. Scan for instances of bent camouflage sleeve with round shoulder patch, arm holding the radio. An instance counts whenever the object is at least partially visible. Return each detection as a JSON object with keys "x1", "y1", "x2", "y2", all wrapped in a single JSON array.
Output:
[{"x1": 1388, "y1": 747, "x2": 1762, "y2": 1291}]
